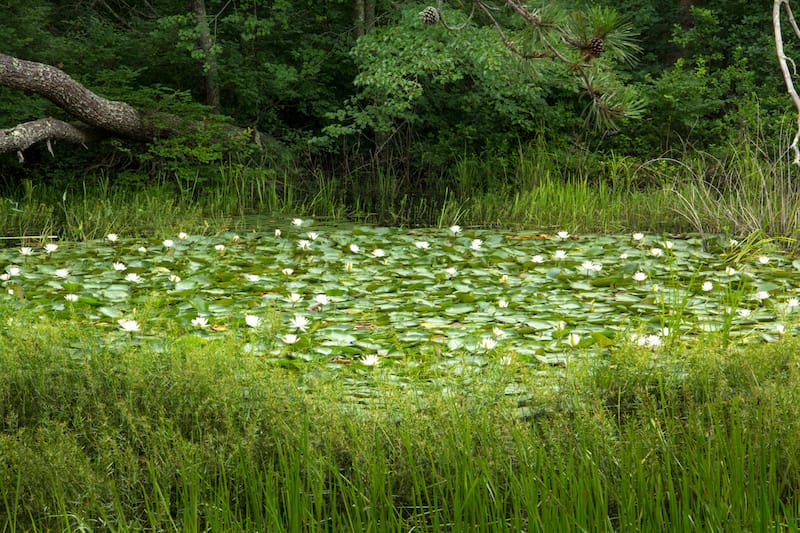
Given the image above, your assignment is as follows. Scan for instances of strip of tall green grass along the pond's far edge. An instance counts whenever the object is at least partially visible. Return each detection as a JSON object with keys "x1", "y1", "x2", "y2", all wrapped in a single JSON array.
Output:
[{"x1": 0, "y1": 132, "x2": 800, "y2": 241}]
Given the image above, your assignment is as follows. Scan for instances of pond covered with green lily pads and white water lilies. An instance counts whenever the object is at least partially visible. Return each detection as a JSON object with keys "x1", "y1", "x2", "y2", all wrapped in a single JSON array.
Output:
[{"x1": 0, "y1": 219, "x2": 800, "y2": 366}]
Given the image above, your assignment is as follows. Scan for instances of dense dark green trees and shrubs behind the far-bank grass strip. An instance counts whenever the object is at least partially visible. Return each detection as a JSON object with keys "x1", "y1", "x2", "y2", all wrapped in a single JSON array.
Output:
[{"x1": 0, "y1": 0, "x2": 790, "y2": 222}]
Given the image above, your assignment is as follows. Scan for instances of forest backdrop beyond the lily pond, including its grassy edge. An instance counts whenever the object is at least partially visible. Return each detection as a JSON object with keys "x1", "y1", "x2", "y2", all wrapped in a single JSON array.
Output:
[{"x1": 0, "y1": 0, "x2": 797, "y2": 236}]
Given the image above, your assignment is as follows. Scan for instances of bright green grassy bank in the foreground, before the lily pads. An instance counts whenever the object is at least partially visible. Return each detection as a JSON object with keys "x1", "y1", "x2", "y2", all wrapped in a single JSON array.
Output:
[{"x1": 0, "y1": 302, "x2": 800, "y2": 531}]
